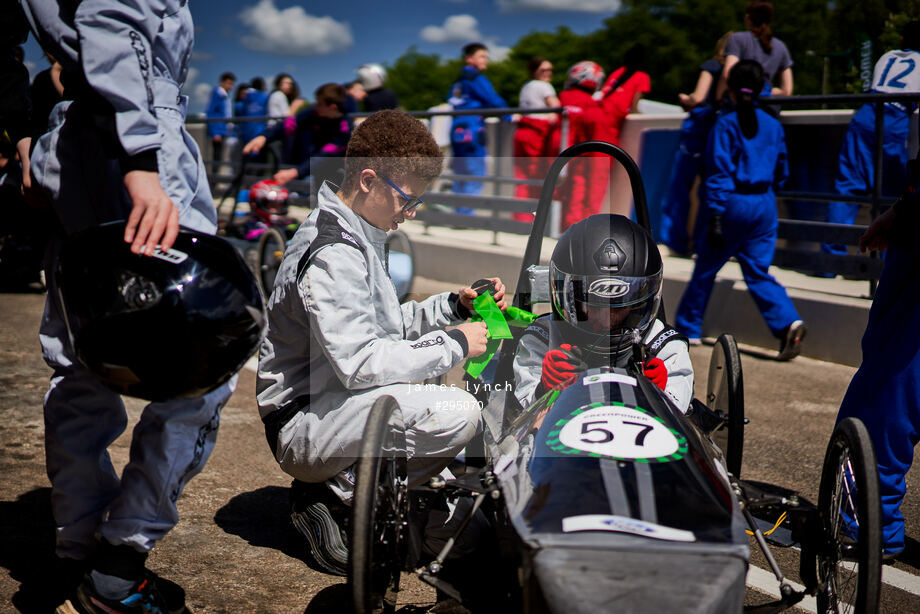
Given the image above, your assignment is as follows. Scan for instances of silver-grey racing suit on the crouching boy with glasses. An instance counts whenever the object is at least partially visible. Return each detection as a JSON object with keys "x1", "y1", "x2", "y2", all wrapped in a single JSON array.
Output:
[{"x1": 256, "y1": 183, "x2": 480, "y2": 500}]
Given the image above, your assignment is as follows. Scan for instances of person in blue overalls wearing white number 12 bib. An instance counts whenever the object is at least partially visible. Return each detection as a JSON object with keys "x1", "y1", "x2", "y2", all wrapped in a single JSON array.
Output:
[{"x1": 821, "y1": 21, "x2": 920, "y2": 262}]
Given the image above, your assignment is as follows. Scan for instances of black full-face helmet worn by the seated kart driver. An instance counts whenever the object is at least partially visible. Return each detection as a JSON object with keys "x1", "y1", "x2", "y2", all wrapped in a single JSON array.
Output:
[{"x1": 550, "y1": 214, "x2": 662, "y2": 366}]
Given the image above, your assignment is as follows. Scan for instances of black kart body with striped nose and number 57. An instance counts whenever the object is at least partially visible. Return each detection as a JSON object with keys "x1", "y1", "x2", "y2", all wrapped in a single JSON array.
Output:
[{"x1": 486, "y1": 368, "x2": 749, "y2": 613}]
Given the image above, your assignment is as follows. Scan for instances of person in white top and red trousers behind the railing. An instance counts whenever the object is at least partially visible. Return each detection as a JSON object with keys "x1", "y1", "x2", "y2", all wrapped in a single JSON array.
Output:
[{"x1": 511, "y1": 56, "x2": 559, "y2": 222}]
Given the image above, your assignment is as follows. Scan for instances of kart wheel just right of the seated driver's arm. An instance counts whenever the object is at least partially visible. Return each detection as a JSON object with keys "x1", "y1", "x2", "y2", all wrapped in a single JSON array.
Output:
[{"x1": 706, "y1": 333, "x2": 744, "y2": 477}]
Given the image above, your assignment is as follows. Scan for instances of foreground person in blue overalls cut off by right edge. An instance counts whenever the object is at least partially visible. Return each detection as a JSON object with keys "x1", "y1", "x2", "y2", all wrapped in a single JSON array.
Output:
[{"x1": 837, "y1": 164, "x2": 920, "y2": 560}]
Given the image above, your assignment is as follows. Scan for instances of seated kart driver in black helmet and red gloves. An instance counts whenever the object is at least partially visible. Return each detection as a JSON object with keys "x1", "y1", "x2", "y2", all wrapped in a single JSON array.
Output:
[{"x1": 514, "y1": 214, "x2": 693, "y2": 413}]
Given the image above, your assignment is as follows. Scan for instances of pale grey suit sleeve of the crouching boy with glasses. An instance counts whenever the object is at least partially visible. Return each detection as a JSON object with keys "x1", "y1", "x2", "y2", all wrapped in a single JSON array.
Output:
[{"x1": 306, "y1": 244, "x2": 464, "y2": 390}]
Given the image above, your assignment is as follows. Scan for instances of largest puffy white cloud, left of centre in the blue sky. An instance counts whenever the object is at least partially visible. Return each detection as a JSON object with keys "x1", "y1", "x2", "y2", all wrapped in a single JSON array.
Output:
[{"x1": 239, "y1": 0, "x2": 354, "y2": 55}]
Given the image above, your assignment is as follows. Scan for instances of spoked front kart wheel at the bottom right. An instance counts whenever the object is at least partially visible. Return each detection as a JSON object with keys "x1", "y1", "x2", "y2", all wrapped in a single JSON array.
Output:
[{"x1": 816, "y1": 418, "x2": 882, "y2": 614}]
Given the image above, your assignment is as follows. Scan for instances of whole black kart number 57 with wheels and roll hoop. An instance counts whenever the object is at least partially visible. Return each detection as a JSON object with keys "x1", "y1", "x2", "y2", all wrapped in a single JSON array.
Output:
[{"x1": 348, "y1": 142, "x2": 881, "y2": 613}]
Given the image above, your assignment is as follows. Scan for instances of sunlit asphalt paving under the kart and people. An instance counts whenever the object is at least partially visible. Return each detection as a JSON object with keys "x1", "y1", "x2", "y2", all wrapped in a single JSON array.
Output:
[{"x1": 0, "y1": 279, "x2": 920, "y2": 613}]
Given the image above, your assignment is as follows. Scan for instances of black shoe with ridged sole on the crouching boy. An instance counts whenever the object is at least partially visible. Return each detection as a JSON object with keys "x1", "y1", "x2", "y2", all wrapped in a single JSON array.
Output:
[{"x1": 291, "y1": 480, "x2": 350, "y2": 576}]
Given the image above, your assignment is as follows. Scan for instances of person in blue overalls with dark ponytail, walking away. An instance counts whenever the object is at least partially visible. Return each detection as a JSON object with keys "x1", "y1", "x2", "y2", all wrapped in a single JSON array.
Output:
[{"x1": 675, "y1": 60, "x2": 805, "y2": 360}]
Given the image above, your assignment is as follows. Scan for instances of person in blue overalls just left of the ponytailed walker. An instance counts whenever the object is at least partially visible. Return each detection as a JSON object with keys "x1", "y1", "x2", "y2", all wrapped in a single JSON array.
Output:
[{"x1": 661, "y1": 32, "x2": 732, "y2": 256}]
